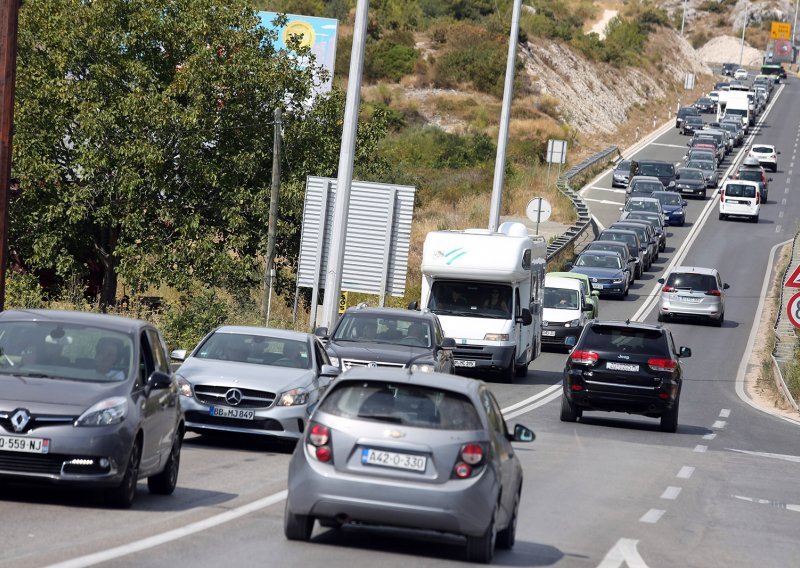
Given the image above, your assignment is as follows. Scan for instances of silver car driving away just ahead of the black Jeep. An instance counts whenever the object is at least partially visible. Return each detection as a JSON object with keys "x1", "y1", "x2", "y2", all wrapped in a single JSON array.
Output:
[{"x1": 658, "y1": 266, "x2": 730, "y2": 327}]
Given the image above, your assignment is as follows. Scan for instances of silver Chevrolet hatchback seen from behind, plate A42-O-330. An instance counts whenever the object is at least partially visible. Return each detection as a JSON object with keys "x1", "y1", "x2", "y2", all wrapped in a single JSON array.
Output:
[{"x1": 284, "y1": 368, "x2": 534, "y2": 562}]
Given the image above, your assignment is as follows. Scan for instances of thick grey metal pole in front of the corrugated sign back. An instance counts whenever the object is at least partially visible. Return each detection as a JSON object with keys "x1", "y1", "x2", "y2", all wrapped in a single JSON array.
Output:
[{"x1": 318, "y1": 0, "x2": 369, "y2": 329}]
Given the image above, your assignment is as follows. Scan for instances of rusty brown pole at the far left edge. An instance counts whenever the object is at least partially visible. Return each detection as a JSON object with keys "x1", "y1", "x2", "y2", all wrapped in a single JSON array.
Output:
[{"x1": 0, "y1": 0, "x2": 19, "y2": 311}]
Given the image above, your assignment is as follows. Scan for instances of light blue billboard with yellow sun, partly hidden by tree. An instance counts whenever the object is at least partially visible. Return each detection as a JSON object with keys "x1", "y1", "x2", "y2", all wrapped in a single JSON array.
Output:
[{"x1": 258, "y1": 12, "x2": 339, "y2": 93}]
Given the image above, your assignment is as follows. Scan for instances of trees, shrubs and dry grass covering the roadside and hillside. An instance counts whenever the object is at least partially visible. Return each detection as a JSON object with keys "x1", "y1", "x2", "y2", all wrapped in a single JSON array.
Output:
[{"x1": 6, "y1": 0, "x2": 724, "y2": 348}]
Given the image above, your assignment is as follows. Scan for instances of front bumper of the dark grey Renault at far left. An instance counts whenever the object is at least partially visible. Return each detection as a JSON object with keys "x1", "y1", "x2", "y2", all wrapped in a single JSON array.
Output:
[{"x1": 0, "y1": 421, "x2": 133, "y2": 487}]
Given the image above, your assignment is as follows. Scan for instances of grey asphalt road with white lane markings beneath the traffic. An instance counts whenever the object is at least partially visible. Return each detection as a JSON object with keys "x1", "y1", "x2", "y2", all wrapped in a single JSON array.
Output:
[{"x1": 0, "y1": 78, "x2": 800, "y2": 568}]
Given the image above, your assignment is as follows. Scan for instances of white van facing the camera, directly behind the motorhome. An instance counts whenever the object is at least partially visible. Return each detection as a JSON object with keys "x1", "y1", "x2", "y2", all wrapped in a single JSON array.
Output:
[{"x1": 542, "y1": 274, "x2": 592, "y2": 349}]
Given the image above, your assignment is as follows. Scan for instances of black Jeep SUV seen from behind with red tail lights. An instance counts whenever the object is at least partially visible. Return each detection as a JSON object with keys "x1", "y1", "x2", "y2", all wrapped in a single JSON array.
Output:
[{"x1": 561, "y1": 320, "x2": 692, "y2": 432}]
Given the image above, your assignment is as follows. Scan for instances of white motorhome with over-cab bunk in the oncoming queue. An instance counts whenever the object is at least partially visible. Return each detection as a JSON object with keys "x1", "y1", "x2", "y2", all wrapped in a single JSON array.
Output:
[{"x1": 421, "y1": 222, "x2": 547, "y2": 382}]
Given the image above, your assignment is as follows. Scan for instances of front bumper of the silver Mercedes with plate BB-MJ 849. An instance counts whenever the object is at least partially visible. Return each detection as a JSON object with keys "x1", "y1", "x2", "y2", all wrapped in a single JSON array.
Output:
[{"x1": 181, "y1": 397, "x2": 313, "y2": 440}]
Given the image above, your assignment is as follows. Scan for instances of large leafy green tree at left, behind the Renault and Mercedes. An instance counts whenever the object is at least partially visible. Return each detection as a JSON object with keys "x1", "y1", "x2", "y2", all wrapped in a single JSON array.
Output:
[{"x1": 10, "y1": 0, "x2": 388, "y2": 305}]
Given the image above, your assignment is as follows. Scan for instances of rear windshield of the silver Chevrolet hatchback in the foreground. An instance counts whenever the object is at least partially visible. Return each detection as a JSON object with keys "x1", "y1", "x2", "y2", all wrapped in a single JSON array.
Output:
[{"x1": 319, "y1": 380, "x2": 483, "y2": 430}]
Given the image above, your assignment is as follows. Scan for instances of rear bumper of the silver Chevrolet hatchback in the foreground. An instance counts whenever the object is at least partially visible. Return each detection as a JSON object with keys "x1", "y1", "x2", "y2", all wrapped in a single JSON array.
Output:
[{"x1": 287, "y1": 447, "x2": 498, "y2": 536}]
